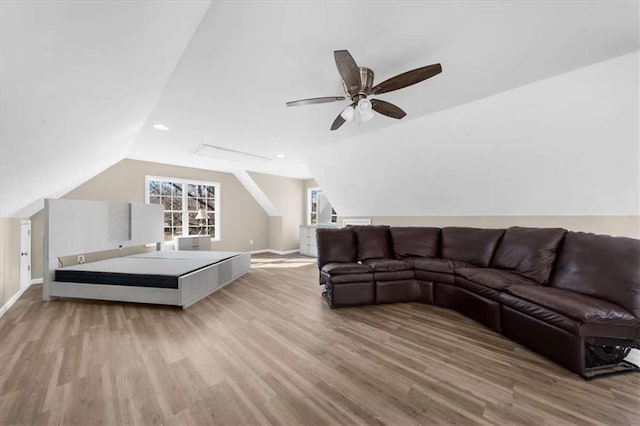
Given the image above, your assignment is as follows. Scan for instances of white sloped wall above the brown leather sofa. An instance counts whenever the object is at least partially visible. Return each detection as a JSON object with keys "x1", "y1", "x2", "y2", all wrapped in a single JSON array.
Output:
[{"x1": 306, "y1": 51, "x2": 639, "y2": 216}]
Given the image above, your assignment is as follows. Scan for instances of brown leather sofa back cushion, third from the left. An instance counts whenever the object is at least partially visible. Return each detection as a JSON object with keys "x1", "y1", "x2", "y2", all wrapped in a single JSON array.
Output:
[{"x1": 390, "y1": 227, "x2": 440, "y2": 259}]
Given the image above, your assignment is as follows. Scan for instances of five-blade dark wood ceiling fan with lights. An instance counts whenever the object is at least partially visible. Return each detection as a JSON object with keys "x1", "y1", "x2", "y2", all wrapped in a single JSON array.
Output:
[{"x1": 287, "y1": 50, "x2": 442, "y2": 130}]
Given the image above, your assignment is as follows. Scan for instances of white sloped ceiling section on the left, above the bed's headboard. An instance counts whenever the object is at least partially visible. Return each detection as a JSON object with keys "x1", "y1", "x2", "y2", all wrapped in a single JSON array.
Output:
[{"x1": 0, "y1": 0, "x2": 209, "y2": 217}]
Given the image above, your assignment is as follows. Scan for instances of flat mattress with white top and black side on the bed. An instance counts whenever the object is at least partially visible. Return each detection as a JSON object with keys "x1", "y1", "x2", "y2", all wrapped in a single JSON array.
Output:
[{"x1": 54, "y1": 251, "x2": 240, "y2": 289}]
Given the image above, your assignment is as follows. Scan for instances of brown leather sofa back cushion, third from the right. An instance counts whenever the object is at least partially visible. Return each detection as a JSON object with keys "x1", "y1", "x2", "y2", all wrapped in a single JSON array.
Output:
[{"x1": 442, "y1": 227, "x2": 504, "y2": 267}]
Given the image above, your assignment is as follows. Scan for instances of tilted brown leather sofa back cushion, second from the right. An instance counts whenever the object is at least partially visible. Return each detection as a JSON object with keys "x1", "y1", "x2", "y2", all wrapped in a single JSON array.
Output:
[{"x1": 491, "y1": 226, "x2": 567, "y2": 285}]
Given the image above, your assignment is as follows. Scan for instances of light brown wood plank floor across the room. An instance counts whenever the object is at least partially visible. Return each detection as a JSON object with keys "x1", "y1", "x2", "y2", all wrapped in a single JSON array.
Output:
[{"x1": 0, "y1": 255, "x2": 640, "y2": 426}]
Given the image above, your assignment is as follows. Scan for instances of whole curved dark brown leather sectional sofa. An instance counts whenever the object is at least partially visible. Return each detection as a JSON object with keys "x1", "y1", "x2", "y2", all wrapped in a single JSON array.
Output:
[{"x1": 317, "y1": 226, "x2": 640, "y2": 378}]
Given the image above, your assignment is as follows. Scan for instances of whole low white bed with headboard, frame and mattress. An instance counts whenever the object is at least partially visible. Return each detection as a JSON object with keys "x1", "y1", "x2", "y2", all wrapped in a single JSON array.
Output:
[{"x1": 43, "y1": 200, "x2": 251, "y2": 308}]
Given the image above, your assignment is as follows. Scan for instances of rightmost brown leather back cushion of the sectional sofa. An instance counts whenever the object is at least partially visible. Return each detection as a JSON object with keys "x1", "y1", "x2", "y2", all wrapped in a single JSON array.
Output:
[{"x1": 551, "y1": 232, "x2": 640, "y2": 318}]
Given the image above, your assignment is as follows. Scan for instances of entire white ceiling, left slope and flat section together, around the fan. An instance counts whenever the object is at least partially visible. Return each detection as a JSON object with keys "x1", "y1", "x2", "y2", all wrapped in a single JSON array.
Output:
[{"x1": 0, "y1": 1, "x2": 639, "y2": 216}]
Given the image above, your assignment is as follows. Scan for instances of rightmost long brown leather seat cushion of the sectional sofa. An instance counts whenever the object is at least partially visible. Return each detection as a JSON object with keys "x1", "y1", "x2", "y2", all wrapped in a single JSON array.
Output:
[{"x1": 506, "y1": 285, "x2": 639, "y2": 326}]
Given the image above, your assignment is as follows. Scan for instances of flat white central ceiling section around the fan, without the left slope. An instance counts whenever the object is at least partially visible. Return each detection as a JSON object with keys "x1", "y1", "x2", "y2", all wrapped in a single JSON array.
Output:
[{"x1": 130, "y1": 1, "x2": 638, "y2": 177}]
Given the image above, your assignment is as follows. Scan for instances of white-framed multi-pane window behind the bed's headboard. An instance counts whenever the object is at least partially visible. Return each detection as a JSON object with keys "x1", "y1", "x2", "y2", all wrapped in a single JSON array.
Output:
[{"x1": 146, "y1": 176, "x2": 220, "y2": 241}]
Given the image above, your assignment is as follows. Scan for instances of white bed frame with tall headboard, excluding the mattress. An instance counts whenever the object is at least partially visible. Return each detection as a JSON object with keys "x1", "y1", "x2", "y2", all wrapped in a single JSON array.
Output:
[{"x1": 42, "y1": 199, "x2": 251, "y2": 308}]
